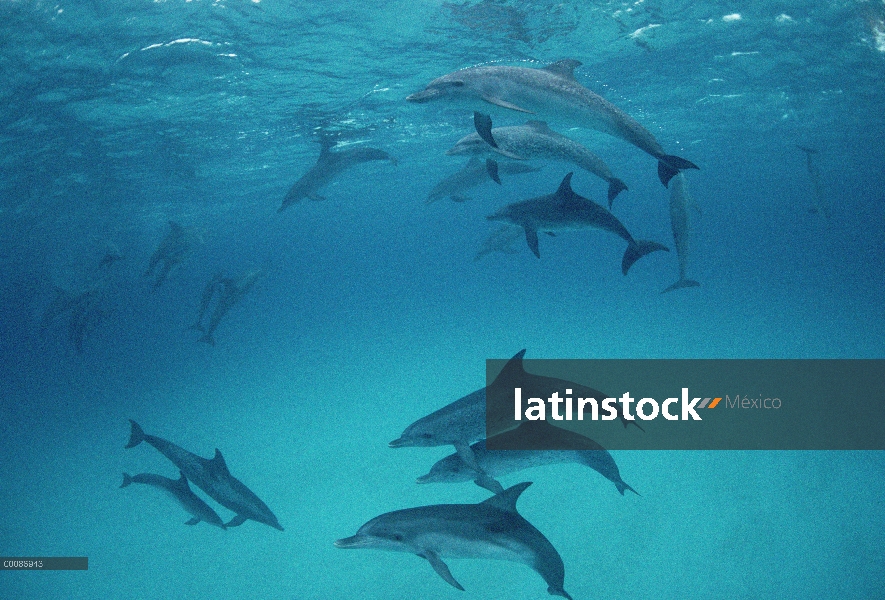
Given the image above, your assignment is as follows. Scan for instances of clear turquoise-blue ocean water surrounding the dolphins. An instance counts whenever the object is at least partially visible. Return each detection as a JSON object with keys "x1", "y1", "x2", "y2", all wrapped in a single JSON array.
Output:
[{"x1": 0, "y1": 0, "x2": 885, "y2": 600}]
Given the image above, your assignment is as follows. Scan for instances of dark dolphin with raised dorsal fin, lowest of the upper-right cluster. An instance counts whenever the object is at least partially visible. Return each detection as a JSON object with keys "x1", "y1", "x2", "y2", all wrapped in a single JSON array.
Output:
[{"x1": 487, "y1": 173, "x2": 670, "y2": 275}]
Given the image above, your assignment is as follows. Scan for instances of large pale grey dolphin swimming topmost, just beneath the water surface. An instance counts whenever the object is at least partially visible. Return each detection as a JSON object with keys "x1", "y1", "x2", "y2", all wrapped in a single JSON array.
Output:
[{"x1": 406, "y1": 59, "x2": 699, "y2": 187}]
